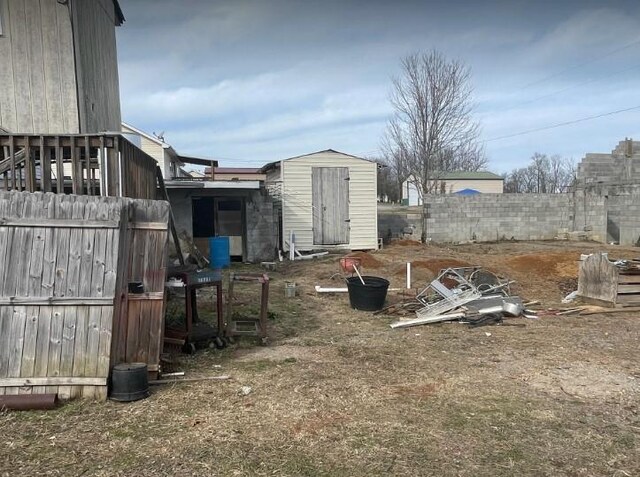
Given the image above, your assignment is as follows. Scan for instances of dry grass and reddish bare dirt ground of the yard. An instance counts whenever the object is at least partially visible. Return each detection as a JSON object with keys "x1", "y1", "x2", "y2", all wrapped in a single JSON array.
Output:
[{"x1": 0, "y1": 242, "x2": 640, "y2": 476}]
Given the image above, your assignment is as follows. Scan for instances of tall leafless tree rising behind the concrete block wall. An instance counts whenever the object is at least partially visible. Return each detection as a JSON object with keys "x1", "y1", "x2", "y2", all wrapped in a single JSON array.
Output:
[{"x1": 383, "y1": 50, "x2": 486, "y2": 241}]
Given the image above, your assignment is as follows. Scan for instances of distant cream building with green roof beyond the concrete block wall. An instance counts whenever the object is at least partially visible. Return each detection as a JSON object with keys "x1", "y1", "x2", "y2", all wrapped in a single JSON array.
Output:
[{"x1": 402, "y1": 171, "x2": 504, "y2": 205}]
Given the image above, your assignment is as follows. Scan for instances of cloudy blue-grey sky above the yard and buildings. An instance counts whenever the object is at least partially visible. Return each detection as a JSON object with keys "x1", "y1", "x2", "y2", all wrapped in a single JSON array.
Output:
[{"x1": 117, "y1": 0, "x2": 640, "y2": 172}]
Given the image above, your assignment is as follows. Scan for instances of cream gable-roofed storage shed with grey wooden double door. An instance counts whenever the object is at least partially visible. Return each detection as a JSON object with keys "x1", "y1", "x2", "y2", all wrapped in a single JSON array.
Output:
[{"x1": 261, "y1": 149, "x2": 378, "y2": 251}]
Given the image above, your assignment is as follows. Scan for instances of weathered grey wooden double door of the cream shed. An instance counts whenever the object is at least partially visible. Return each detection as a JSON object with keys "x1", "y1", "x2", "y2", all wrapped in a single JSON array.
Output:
[{"x1": 311, "y1": 167, "x2": 349, "y2": 245}]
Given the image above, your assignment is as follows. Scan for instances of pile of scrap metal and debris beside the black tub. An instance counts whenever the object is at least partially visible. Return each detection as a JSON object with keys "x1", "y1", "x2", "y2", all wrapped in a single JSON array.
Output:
[{"x1": 390, "y1": 267, "x2": 537, "y2": 328}]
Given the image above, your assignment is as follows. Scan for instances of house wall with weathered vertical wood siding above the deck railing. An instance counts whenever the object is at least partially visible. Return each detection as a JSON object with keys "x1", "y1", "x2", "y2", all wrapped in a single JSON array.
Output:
[{"x1": 0, "y1": 0, "x2": 124, "y2": 134}]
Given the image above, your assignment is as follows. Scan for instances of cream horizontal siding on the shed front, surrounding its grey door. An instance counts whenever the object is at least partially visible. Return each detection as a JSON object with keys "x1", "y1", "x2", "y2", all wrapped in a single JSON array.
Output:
[{"x1": 278, "y1": 151, "x2": 378, "y2": 250}]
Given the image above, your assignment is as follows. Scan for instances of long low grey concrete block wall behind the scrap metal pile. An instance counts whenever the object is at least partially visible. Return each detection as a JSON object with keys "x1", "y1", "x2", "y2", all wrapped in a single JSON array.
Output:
[{"x1": 427, "y1": 194, "x2": 573, "y2": 242}]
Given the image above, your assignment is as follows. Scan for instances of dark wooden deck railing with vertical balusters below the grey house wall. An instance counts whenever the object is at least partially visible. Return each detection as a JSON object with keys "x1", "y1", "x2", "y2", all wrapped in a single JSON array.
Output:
[{"x1": 0, "y1": 134, "x2": 157, "y2": 199}]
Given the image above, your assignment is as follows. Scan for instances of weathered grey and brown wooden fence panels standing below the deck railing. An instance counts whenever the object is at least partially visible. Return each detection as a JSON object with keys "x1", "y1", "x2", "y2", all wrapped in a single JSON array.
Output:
[{"x1": 0, "y1": 192, "x2": 169, "y2": 399}]
